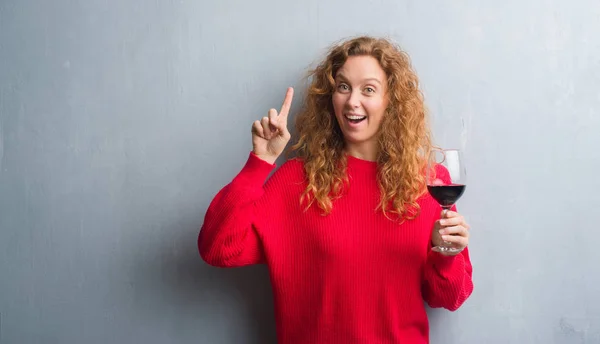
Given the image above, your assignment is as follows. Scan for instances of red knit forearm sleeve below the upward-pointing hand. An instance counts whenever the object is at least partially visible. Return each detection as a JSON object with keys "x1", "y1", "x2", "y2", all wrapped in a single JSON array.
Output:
[{"x1": 198, "y1": 152, "x2": 275, "y2": 267}]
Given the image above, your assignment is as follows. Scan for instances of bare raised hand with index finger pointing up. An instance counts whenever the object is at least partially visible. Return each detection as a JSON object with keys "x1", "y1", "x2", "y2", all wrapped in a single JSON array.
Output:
[{"x1": 252, "y1": 87, "x2": 294, "y2": 164}]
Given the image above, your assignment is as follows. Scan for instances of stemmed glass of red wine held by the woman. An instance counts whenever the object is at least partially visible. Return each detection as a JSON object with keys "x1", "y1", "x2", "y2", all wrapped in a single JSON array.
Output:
[{"x1": 427, "y1": 149, "x2": 467, "y2": 252}]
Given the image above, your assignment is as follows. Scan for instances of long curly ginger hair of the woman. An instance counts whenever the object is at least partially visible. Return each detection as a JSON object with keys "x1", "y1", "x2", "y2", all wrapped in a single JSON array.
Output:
[{"x1": 291, "y1": 36, "x2": 431, "y2": 221}]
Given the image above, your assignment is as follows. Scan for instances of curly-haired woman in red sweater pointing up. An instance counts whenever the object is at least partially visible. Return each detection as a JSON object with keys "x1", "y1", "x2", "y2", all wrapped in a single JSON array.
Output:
[{"x1": 198, "y1": 37, "x2": 473, "y2": 344}]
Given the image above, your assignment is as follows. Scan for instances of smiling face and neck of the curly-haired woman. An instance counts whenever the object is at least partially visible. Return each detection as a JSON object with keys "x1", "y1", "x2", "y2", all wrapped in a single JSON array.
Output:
[{"x1": 332, "y1": 56, "x2": 388, "y2": 161}]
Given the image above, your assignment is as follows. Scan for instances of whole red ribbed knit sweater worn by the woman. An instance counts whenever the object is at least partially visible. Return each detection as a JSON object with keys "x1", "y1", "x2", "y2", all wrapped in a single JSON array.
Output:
[{"x1": 198, "y1": 153, "x2": 473, "y2": 344}]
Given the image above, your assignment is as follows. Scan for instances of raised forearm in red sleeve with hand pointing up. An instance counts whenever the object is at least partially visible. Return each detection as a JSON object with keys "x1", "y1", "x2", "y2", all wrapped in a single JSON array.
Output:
[{"x1": 198, "y1": 88, "x2": 293, "y2": 267}]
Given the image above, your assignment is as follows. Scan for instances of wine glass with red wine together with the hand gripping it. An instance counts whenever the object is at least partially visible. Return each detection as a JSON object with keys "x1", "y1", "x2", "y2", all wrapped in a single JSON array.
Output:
[{"x1": 427, "y1": 149, "x2": 469, "y2": 255}]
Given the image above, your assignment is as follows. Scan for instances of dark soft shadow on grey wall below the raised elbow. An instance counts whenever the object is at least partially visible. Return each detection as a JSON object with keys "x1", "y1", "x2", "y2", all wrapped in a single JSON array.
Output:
[{"x1": 128, "y1": 222, "x2": 276, "y2": 344}]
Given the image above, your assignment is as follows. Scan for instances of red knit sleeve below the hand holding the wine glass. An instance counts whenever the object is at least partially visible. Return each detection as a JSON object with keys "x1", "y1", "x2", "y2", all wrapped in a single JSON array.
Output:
[{"x1": 423, "y1": 248, "x2": 473, "y2": 311}]
